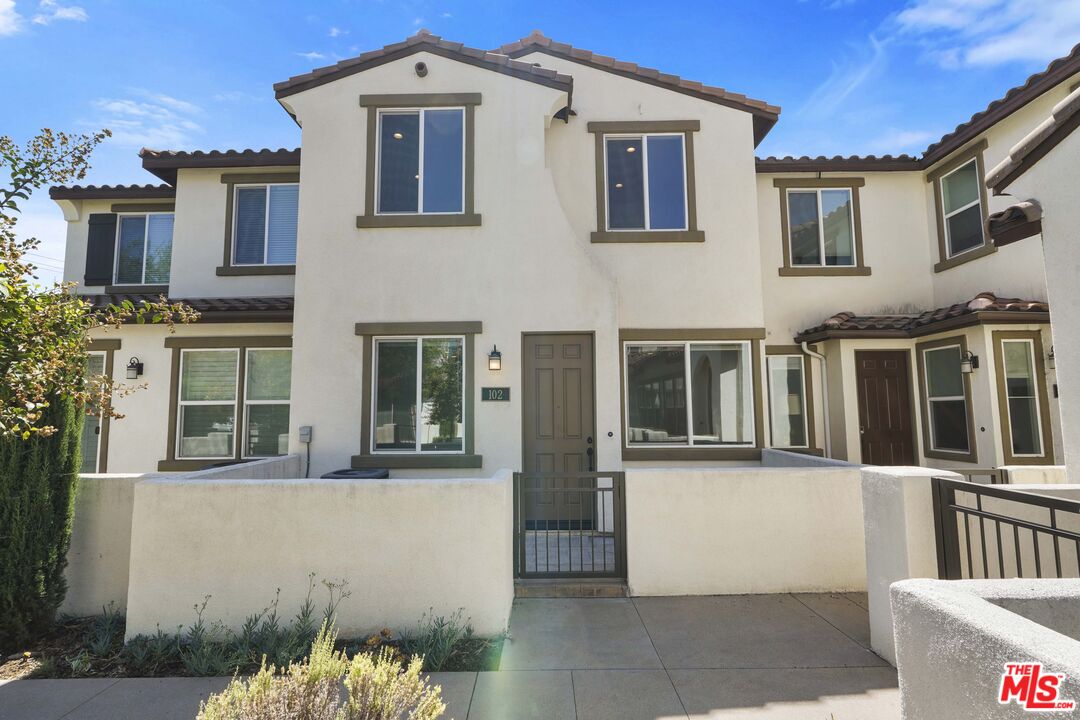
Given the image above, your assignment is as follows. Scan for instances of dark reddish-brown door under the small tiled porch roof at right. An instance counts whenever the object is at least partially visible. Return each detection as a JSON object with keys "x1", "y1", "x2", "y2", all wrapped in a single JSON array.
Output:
[{"x1": 855, "y1": 350, "x2": 915, "y2": 465}]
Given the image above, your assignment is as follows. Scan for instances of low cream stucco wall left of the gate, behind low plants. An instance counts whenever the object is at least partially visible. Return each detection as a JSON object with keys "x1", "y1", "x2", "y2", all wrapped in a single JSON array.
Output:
[{"x1": 127, "y1": 471, "x2": 514, "y2": 638}]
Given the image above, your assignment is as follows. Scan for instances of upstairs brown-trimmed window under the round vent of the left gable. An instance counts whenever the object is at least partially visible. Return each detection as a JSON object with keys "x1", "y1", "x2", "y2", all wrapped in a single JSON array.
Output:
[{"x1": 356, "y1": 93, "x2": 481, "y2": 228}]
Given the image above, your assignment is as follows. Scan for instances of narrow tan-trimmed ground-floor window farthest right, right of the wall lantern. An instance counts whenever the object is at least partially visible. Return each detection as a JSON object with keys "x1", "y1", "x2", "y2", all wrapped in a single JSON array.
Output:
[{"x1": 994, "y1": 330, "x2": 1053, "y2": 465}]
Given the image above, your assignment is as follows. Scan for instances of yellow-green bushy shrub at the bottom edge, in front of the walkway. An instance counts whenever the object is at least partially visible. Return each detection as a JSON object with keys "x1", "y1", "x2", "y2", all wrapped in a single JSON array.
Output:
[{"x1": 198, "y1": 624, "x2": 446, "y2": 720}]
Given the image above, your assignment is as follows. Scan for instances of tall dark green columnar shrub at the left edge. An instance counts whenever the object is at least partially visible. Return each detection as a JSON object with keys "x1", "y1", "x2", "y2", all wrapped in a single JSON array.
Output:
[{"x1": 0, "y1": 400, "x2": 84, "y2": 656}]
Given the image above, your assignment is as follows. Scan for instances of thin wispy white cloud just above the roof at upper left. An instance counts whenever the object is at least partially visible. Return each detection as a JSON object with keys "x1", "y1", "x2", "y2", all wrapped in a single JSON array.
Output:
[{"x1": 93, "y1": 87, "x2": 203, "y2": 149}]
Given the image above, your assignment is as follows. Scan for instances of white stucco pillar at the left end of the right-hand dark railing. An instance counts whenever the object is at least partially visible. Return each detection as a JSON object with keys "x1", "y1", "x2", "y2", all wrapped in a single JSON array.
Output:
[{"x1": 862, "y1": 467, "x2": 960, "y2": 665}]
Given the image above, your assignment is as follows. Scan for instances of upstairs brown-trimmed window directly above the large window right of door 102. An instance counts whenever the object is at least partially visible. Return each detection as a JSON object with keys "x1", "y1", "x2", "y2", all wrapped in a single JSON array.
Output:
[{"x1": 589, "y1": 121, "x2": 704, "y2": 243}]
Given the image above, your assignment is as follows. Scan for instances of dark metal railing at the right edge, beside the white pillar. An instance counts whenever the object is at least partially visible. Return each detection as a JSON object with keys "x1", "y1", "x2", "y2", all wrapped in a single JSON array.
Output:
[{"x1": 933, "y1": 477, "x2": 1080, "y2": 580}]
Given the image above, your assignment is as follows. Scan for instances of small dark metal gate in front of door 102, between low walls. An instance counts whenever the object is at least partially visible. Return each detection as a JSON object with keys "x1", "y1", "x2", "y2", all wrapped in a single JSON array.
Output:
[{"x1": 514, "y1": 473, "x2": 626, "y2": 578}]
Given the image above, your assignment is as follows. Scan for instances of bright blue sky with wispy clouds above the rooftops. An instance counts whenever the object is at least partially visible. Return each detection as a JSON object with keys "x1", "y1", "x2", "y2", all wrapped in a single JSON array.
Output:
[{"x1": 8, "y1": 0, "x2": 1080, "y2": 281}]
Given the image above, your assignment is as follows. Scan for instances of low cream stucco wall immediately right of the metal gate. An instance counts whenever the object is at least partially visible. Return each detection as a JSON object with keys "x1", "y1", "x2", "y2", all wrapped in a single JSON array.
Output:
[{"x1": 626, "y1": 466, "x2": 866, "y2": 595}]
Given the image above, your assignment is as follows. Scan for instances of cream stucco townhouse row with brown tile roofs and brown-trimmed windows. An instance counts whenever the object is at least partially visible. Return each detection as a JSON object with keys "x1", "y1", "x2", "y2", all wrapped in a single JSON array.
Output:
[{"x1": 51, "y1": 31, "x2": 1080, "y2": 477}]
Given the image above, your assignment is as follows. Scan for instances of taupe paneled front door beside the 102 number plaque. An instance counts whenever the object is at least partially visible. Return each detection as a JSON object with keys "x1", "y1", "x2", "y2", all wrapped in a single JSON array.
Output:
[{"x1": 522, "y1": 332, "x2": 596, "y2": 525}]
